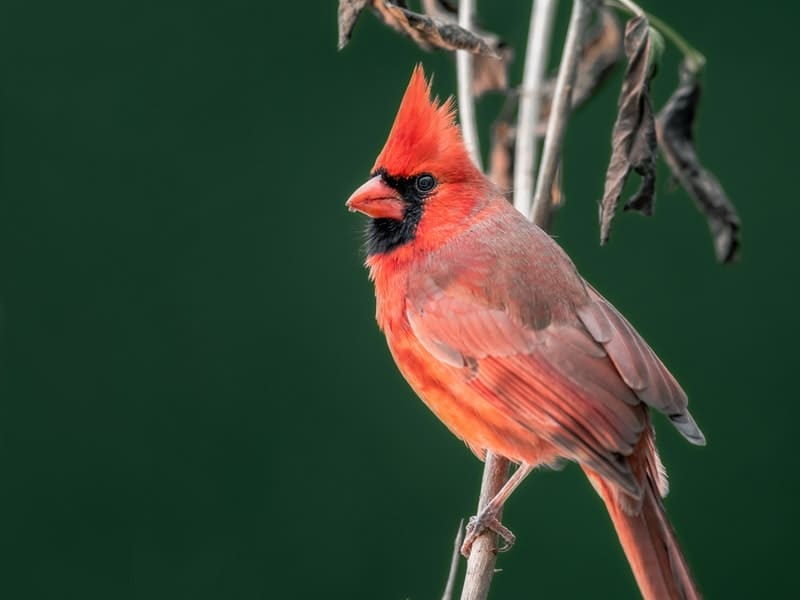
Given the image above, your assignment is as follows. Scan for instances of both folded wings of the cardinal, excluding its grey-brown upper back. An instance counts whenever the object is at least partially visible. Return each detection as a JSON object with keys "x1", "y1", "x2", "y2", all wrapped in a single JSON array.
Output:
[{"x1": 406, "y1": 260, "x2": 703, "y2": 498}]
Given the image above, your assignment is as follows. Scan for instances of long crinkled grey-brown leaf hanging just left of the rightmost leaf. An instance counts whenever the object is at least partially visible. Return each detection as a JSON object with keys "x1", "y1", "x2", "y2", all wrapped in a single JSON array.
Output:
[{"x1": 600, "y1": 16, "x2": 658, "y2": 244}]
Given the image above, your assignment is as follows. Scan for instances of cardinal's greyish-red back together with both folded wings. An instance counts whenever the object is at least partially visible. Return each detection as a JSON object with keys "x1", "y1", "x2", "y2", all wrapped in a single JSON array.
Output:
[{"x1": 405, "y1": 211, "x2": 705, "y2": 498}]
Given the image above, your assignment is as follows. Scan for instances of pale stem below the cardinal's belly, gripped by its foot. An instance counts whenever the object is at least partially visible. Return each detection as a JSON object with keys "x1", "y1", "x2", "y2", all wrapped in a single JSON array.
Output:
[{"x1": 461, "y1": 452, "x2": 509, "y2": 600}]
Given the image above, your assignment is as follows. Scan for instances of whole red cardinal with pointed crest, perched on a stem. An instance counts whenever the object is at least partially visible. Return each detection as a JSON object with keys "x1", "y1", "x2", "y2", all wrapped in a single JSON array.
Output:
[{"x1": 347, "y1": 67, "x2": 705, "y2": 599}]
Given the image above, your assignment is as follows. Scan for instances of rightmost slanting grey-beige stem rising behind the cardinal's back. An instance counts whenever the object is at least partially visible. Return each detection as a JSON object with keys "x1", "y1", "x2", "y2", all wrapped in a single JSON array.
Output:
[{"x1": 531, "y1": 0, "x2": 593, "y2": 227}]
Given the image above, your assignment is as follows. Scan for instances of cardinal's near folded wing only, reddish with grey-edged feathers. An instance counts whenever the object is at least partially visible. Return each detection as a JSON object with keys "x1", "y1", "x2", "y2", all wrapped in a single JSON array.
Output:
[{"x1": 406, "y1": 274, "x2": 646, "y2": 496}]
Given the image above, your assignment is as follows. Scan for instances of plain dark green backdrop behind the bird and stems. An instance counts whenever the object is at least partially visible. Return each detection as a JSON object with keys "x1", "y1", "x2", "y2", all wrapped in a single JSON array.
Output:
[{"x1": 0, "y1": 0, "x2": 800, "y2": 599}]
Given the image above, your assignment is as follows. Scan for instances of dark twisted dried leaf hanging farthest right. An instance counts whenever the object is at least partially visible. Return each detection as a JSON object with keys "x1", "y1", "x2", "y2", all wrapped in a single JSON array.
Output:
[{"x1": 656, "y1": 63, "x2": 740, "y2": 263}]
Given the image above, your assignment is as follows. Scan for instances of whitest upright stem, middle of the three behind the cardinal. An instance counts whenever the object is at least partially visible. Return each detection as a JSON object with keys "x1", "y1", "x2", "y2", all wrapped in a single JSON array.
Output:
[{"x1": 514, "y1": 0, "x2": 556, "y2": 217}]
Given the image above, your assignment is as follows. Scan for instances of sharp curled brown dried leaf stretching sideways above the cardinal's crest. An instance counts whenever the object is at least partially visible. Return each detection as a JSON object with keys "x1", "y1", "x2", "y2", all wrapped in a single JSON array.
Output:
[{"x1": 372, "y1": 0, "x2": 500, "y2": 58}]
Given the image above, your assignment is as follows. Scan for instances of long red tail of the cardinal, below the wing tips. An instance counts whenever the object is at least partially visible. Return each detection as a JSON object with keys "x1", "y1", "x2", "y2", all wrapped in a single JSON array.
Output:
[{"x1": 584, "y1": 468, "x2": 701, "y2": 600}]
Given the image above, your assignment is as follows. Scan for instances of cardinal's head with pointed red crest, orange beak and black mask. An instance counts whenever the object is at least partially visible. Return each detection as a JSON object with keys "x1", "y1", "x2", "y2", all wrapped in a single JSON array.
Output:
[{"x1": 347, "y1": 65, "x2": 490, "y2": 256}]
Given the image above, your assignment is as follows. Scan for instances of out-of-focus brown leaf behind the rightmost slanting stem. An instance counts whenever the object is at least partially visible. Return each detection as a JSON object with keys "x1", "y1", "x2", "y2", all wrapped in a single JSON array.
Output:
[{"x1": 536, "y1": 9, "x2": 622, "y2": 137}]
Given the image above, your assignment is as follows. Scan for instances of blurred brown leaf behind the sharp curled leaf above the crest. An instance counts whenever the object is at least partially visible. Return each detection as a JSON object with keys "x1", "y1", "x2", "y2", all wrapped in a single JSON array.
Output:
[{"x1": 422, "y1": 0, "x2": 514, "y2": 96}]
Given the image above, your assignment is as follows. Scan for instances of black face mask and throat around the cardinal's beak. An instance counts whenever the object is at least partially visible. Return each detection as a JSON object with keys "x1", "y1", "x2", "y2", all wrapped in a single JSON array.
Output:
[{"x1": 365, "y1": 169, "x2": 424, "y2": 256}]
